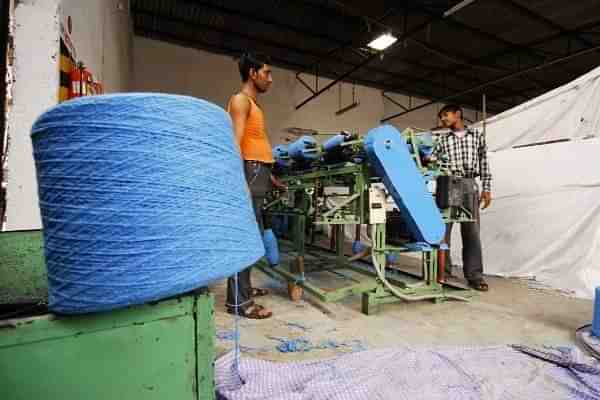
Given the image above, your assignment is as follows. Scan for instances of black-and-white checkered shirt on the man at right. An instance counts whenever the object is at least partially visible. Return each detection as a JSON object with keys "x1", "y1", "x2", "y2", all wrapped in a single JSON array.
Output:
[{"x1": 433, "y1": 128, "x2": 492, "y2": 192}]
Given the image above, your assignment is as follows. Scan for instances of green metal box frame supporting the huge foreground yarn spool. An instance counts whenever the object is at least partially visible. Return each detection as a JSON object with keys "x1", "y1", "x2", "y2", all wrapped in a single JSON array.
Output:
[{"x1": 0, "y1": 231, "x2": 215, "y2": 400}]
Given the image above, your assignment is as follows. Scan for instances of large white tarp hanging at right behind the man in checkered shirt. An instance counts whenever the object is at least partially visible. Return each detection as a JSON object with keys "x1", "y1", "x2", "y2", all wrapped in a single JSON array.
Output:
[{"x1": 453, "y1": 68, "x2": 600, "y2": 298}]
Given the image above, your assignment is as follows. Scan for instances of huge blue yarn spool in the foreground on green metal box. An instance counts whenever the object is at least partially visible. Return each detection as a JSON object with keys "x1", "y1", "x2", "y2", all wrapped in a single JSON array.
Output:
[{"x1": 32, "y1": 93, "x2": 264, "y2": 313}]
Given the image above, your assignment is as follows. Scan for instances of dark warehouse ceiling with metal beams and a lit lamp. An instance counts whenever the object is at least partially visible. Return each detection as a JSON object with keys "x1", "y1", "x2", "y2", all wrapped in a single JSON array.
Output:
[{"x1": 131, "y1": 0, "x2": 600, "y2": 119}]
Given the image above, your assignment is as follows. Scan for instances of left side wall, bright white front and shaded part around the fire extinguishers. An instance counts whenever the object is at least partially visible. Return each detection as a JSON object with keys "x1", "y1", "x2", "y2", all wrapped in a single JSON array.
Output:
[{"x1": 5, "y1": 0, "x2": 133, "y2": 230}]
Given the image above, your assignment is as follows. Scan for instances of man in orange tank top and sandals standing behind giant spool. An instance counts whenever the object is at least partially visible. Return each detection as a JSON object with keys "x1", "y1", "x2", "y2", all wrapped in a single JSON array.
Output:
[{"x1": 227, "y1": 54, "x2": 279, "y2": 319}]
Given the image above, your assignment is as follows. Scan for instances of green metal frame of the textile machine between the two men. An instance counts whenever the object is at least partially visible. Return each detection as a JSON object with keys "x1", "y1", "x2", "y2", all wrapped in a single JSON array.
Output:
[{"x1": 259, "y1": 130, "x2": 472, "y2": 314}]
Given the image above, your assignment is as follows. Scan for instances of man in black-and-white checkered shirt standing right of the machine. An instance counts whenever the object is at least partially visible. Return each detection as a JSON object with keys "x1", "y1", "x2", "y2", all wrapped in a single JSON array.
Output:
[{"x1": 433, "y1": 104, "x2": 492, "y2": 291}]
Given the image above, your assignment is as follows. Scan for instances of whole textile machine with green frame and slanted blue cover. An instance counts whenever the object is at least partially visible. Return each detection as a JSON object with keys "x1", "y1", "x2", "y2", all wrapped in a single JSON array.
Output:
[{"x1": 261, "y1": 126, "x2": 472, "y2": 314}]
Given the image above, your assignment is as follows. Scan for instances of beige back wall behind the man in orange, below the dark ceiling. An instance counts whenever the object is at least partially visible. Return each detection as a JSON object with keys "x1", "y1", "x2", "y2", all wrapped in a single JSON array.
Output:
[{"x1": 133, "y1": 36, "x2": 383, "y2": 145}]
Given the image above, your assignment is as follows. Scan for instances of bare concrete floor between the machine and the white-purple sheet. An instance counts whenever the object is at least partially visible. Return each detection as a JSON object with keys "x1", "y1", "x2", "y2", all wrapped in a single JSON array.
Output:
[{"x1": 212, "y1": 255, "x2": 593, "y2": 361}]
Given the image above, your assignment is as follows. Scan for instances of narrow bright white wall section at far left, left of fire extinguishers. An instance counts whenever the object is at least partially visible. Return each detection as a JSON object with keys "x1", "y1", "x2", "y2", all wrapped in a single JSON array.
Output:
[{"x1": 6, "y1": 0, "x2": 59, "y2": 230}]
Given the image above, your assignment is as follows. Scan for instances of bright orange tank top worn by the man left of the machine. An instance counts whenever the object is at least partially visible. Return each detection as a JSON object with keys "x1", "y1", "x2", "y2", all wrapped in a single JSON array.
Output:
[{"x1": 227, "y1": 95, "x2": 274, "y2": 163}]
